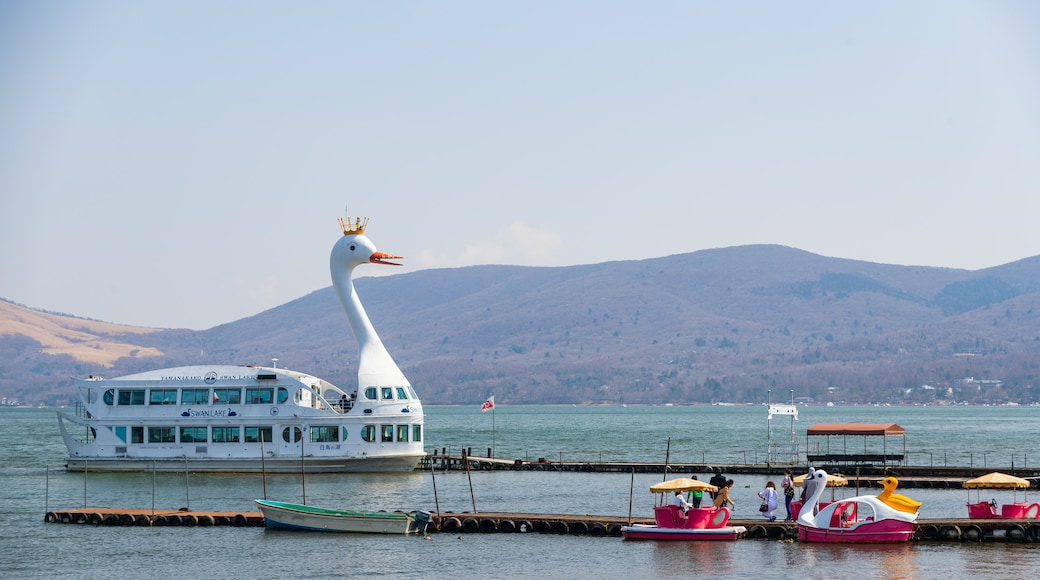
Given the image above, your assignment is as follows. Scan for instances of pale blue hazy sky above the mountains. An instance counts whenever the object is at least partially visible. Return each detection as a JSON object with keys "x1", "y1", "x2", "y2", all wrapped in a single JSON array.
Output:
[{"x1": 0, "y1": 0, "x2": 1040, "y2": 329}]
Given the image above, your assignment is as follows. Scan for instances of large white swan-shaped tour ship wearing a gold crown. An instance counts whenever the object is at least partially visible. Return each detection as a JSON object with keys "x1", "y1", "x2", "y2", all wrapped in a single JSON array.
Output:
[{"x1": 58, "y1": 218, "x2": 425, "y2": 473}]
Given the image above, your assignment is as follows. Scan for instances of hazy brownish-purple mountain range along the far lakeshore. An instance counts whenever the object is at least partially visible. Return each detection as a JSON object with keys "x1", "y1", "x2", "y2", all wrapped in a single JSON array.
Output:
[{"x1": 0, "y1": 245, "x2": 1040, "y2": 405}]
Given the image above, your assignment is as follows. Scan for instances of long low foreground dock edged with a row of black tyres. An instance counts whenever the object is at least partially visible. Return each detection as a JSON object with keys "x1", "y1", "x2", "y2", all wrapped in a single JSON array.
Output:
[{"x1": 44, "y1": 507, "x2": 1040, "y2": 543}]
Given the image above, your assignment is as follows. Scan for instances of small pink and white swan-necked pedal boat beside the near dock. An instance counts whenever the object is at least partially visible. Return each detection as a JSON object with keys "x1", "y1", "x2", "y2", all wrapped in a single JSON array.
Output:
[{"x1": 797, "y1": 469, "x2": 919, "y2": 544}]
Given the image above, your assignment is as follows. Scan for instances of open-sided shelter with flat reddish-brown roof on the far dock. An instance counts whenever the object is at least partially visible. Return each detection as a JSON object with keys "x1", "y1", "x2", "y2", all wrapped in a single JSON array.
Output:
[{"x1": 805, "y1": 423, "x2": 907, "y2": 464}]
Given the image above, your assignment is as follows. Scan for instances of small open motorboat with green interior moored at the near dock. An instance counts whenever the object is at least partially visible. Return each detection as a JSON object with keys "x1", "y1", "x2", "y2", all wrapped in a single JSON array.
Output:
[{"x1": 254, "y1": 500, "x2": 430, "y2": 534}]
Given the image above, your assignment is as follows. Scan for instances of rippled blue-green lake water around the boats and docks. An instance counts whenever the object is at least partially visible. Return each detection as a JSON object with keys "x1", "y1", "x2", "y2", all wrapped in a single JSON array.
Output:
[{"x1": 0, "y1": 405, "x2": 1040, "y2": 578}]
